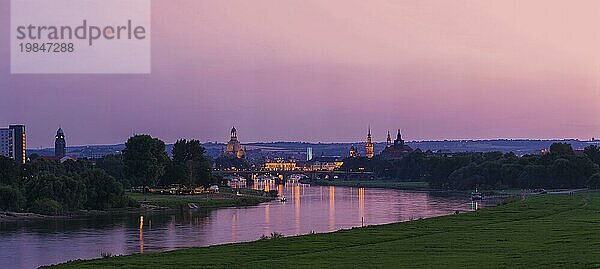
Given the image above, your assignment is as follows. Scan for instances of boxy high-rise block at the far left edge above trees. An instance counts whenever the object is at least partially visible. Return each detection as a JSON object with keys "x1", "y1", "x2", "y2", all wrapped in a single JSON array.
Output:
[{"x1": 0, "y1": 125, "x2": 27, "y2": 164}]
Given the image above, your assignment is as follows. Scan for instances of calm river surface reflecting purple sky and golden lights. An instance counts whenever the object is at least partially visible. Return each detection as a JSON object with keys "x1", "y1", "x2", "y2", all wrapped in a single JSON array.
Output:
[{"x1": 0, "y1": 183, "x2": 488, "y2": 268}]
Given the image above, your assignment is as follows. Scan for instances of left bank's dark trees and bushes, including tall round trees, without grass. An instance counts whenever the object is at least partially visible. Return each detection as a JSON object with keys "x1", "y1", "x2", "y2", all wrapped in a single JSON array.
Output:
[{"x1": 0, "y1": 135, "x2": 216, "y2": 215}]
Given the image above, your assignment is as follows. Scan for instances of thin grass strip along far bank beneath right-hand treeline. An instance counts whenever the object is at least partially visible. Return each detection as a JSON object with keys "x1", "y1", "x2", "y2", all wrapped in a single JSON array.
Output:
[{"x1": 313, "y1": 180, "x2": 429, "y2": 191}]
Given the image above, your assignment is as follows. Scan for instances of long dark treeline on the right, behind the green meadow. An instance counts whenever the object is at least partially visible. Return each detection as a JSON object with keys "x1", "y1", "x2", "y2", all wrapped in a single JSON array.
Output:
[{"x1": 341, "y1": 143, "x2": 600, "y2": 190}]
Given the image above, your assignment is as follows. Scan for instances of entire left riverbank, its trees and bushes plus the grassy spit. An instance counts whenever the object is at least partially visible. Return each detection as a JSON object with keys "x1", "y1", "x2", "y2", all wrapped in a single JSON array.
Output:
[{"x1": 0, "y1": 135, "x2": 271, "y2": 221}]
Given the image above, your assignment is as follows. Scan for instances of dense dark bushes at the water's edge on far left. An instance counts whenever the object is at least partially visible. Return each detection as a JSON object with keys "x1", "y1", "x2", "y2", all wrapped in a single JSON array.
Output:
[{"x1": 0, "y1": 156, "x2": 133, "y2": 214}]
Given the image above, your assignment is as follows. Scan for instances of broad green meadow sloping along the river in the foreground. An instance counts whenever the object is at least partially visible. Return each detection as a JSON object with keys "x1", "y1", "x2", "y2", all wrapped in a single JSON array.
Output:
[{"x1": 48, "y1": 193, "x2": 600, "y2": 268}]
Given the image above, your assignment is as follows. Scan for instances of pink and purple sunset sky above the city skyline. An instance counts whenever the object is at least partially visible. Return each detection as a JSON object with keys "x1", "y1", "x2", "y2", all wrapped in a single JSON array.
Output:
[{"x1": 0, "y1": 0, "x2": 600, "y2": 148}]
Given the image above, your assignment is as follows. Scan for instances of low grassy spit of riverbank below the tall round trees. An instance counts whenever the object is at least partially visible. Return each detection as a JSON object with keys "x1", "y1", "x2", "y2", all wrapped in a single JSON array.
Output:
[{"x1": 129, "y1": 189, "x2": 271, "y2": 208}]
